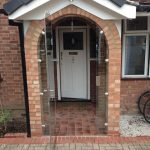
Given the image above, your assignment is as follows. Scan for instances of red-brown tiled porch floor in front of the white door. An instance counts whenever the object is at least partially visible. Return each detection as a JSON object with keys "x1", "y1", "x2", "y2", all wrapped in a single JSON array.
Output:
[{"x1": 42, "y1": 102, "x2": 104, "y2": 136}]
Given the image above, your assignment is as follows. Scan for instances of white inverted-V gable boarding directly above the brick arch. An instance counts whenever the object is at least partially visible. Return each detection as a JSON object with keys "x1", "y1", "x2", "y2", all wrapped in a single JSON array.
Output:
[{"x1": 17, "y1": 0, "x2": 124, "y2": 20}]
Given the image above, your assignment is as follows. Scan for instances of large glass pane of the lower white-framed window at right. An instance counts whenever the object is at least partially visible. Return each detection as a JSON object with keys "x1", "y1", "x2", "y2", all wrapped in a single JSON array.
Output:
[{"x1": 125, "y1": 35, "x2": 146, "y2": 75}]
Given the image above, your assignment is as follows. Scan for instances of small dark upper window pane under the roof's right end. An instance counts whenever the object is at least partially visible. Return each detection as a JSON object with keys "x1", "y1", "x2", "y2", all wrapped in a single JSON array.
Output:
[{"x1": 126, "y1": 17, "x2": 148, "y2": 31}]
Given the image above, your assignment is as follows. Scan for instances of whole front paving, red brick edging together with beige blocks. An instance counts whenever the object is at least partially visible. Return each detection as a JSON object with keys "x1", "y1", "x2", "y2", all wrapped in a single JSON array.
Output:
[{"x1": 0, "y1": 136, "x2": 150, "y2": 150}]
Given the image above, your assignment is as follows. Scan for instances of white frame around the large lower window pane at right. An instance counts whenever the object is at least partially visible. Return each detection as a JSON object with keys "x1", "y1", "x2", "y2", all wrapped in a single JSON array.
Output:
[{"x1": 122, "y1": 33, "x2": 149, "y2": 78}]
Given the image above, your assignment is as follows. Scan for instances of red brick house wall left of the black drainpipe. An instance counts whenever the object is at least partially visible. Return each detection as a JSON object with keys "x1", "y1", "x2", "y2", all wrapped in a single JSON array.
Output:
[{"x1": 0, "y1": 0, "x2": 25, "y2": 117}]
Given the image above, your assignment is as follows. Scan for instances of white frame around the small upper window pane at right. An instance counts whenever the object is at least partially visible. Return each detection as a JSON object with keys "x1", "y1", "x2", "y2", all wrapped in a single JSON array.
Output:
[{"x1": 124, "y1": 16, "x2": 150, "y2": 33}]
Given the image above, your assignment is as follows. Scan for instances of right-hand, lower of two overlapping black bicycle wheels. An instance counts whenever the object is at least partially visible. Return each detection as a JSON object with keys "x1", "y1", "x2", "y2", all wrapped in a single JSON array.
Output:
[{"x1": 143, "y1": 99, "x2": 150, "y2": 123}]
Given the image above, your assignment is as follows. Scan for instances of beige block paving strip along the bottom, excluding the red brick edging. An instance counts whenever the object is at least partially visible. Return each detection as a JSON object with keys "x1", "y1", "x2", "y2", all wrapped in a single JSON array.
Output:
[{"x1": 0, "y1": 143, "x2": 150, "y2": 150}]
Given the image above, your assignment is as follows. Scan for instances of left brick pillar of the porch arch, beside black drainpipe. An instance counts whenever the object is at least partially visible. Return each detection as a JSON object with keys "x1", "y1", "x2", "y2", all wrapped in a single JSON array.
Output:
[{"x1": 25, "y1": 21, "x2": 43, "y2": 136}]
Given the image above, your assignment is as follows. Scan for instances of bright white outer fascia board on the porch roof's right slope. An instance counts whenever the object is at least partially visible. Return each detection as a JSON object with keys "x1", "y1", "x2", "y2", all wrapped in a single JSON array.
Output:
[{"x1": 93, "y1": 0, "x2": 136, "y2": 19}]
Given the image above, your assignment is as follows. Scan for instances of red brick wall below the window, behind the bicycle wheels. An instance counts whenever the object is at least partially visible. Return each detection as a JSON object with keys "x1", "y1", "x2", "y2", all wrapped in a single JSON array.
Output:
[{"x1": 121, "y1": 80, "x2": 150, "y2": 114}]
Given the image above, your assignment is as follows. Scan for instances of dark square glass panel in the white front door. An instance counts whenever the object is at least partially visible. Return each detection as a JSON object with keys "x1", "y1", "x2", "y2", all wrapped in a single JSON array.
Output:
[{"x1": 63, "y1": 32, "x2": 83, "y2": 50}]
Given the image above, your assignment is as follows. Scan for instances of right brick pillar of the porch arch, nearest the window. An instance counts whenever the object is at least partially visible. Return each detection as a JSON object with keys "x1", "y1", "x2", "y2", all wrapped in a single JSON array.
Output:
[{"x1": 104, "y1": 22, "x2": 121, "y2": 135}]
